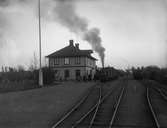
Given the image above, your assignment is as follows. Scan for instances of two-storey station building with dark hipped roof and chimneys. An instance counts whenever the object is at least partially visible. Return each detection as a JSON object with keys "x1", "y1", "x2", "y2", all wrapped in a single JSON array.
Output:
[{"x1": 47, "y1": 40, "x2": 97, "y2": 80}]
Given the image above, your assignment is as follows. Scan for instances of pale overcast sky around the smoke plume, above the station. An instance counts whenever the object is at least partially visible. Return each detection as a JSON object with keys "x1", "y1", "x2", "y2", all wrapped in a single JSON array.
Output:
[{"x1": 0, "y1": 0, "x2": 167, "y2": 68}]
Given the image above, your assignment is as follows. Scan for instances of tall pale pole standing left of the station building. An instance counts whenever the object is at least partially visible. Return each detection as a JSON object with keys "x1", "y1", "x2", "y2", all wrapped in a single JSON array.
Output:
[{"x1": 38, "y1": 0, "x2": 43, "y2": 86}]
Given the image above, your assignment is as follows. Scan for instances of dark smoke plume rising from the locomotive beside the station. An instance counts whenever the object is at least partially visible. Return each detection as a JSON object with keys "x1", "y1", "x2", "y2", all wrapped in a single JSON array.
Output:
[{"x1": 53, "y1": 0, "x2": 105, "y2": 67}]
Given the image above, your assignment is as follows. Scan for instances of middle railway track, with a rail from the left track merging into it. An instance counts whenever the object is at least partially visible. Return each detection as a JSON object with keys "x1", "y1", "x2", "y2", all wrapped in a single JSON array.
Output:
[{"x1": 73, "y1": 80, "x2": 125, "y2": 128}]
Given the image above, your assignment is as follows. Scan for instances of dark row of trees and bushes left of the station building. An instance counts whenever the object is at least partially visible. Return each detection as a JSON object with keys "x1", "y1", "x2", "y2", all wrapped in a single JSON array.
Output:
[{"x1": 0, "y1": 66, "x2": 54, "y2": 84}]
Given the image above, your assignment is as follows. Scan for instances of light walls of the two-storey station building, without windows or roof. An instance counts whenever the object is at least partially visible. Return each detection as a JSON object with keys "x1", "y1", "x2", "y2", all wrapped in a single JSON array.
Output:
[{"x1": 49, "y1": 57, "x2": 96, "y2": 80}]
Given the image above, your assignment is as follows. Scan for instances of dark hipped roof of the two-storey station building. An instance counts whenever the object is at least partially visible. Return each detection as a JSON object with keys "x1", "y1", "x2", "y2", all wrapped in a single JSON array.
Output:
[{"x1": 46, "y1": 40, "x2": 97, "y2": 60}]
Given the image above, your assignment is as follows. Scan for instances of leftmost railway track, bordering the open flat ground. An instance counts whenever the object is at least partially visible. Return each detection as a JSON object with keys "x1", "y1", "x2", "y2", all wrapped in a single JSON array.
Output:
[{"x1": 51, "y1": 85, "x2": 101, "y2": 128}]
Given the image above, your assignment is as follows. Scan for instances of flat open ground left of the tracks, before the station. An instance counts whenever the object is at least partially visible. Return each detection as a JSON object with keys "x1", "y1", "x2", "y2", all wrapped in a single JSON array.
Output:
[{"x1": 0, "y1": 82, "x2": 93, "y2": 128}]
